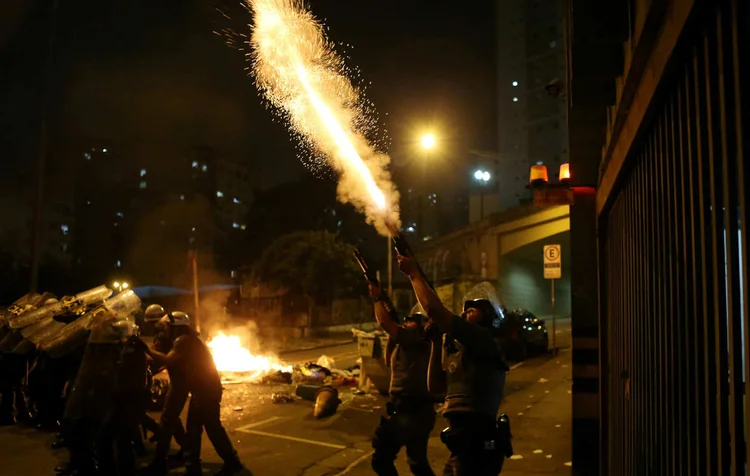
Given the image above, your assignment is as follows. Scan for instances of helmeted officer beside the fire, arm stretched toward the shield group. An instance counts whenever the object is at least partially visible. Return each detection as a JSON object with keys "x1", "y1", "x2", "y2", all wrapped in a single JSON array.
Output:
[{"x1": 140, "y1": 312, "x2": 245, "y2": 476}]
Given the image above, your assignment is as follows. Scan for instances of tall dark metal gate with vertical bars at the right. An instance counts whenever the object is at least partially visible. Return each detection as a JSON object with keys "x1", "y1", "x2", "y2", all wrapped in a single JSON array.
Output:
[{"x1": 598, "y1": 0, "x2": 750, "y2": 476}]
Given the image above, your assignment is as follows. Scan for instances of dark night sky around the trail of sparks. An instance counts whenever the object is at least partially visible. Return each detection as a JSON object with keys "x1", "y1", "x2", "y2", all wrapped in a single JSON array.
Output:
[{"x1": 0, "y1": 0, "x2": 496, "y2": 192}]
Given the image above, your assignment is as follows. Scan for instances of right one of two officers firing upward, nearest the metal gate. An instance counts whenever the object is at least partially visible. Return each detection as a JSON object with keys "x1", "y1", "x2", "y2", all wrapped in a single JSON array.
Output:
[{"x1": 398, "y1": 256, "x2": 512, "y2": 476}]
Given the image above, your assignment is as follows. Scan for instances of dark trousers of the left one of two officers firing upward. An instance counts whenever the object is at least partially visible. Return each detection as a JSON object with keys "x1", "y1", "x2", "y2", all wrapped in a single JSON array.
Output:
[{"x1": 372, "y1": 398, "x2": 435, "y2": 476}]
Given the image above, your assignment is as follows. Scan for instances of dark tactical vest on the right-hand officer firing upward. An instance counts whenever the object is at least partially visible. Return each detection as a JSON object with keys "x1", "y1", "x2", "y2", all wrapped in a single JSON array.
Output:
[{"x1": 443, "y1": 335, "x2": 505, "y2": 419}]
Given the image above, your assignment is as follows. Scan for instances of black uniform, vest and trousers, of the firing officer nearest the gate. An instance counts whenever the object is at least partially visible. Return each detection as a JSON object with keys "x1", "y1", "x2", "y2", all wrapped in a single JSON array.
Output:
[{"x1": 441, "y1": 317, "x2": 510, "y2": 476}]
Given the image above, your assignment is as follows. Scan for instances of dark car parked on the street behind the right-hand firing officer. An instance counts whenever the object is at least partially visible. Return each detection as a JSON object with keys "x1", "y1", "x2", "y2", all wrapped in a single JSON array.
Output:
[{"x1": 500, "y1": 309, "x2": 549, "y2": 362}]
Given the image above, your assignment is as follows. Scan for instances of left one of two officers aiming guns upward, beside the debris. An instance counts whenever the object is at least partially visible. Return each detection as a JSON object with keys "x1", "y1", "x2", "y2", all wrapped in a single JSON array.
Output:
[{"x1": 369, "y1": 282, "x2": 435, "y2": 476}]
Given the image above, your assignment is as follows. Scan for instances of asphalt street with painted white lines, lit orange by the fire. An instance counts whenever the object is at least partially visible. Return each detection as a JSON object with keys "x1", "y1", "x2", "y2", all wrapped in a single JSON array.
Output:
[{"x1": 0, "y1": 320, "x2": 570, "y2": 476}]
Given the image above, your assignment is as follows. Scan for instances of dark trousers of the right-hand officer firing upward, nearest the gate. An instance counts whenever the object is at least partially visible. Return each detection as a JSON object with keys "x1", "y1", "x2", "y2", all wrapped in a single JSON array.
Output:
[{"x1": 443, "y1": 413, "x2": 505, "y2": 476}]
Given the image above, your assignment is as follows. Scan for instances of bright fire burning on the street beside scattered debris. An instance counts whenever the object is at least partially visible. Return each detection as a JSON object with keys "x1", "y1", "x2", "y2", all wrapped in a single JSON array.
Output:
[{"x1": 207, "y1": 332, "x2": 292, "y2": 380}]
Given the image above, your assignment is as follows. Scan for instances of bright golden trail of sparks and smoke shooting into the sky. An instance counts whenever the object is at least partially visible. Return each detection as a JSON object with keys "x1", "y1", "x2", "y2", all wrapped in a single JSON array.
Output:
[{"x1": 247, "y1": 0, "x2": 398, "y2": 235}]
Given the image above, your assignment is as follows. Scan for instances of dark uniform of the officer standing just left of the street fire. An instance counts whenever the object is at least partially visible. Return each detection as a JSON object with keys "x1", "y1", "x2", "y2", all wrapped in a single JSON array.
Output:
[{"x1": 170, "y1": 331, "x2": 242, "y2": 473}]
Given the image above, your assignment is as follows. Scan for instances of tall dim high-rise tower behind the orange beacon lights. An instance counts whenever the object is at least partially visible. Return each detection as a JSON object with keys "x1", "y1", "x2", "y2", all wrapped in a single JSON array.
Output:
[{"x1": 497, "y1": 0, "x2": 568, "y2": 210}]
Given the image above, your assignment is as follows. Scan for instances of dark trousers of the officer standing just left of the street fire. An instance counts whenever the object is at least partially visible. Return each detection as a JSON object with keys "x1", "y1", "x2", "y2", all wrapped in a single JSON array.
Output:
[{"x1": 185, "y1": 393, "x2": 237, "y2": 470}]
